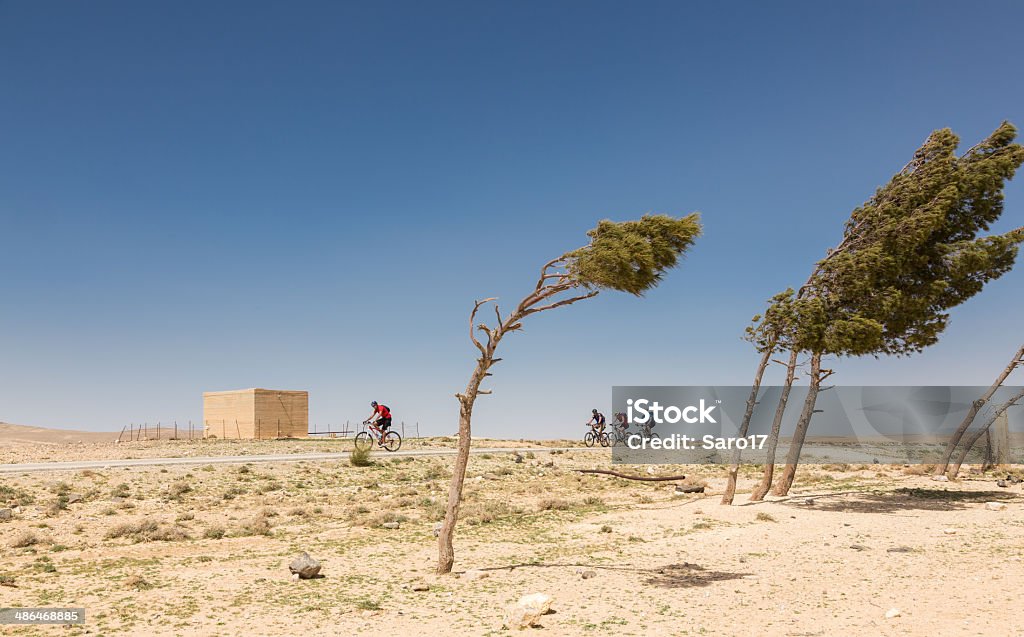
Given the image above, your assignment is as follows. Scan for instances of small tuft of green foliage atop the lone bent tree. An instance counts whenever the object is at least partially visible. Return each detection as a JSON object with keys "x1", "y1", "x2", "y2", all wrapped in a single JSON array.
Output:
[{"x1": 564, "y1": 213, "x2": 700, "y2": 296}]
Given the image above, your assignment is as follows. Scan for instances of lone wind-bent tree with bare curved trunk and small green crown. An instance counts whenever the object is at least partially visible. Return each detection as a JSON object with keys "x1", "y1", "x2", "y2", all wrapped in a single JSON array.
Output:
[{"x1": 437, "y1": 213, "x2": 700, "y2": 574}]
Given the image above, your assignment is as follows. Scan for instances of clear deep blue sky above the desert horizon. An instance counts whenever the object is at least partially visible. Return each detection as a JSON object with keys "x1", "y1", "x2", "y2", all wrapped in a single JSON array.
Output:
[{"x1": 0, "y1": 0, "x2": 1024, "y2": 437}]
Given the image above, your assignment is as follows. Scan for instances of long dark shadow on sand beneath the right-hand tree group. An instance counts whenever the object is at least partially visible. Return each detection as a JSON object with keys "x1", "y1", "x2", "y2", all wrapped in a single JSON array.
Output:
[{"x1": 779, "y1": 487, "x2": 1021, "y2": 513}]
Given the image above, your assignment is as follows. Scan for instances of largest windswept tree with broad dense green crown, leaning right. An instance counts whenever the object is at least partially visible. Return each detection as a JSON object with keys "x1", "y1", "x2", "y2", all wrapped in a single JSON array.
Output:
[{"x1": 741, "y1": 122, "x2": 1024, "y2": 501}]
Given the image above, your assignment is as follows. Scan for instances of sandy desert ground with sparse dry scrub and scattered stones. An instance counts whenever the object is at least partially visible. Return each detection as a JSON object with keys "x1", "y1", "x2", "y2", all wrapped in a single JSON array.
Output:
[{"x1": 0, "y1": 429, "x2": 1024, "y2": 637}]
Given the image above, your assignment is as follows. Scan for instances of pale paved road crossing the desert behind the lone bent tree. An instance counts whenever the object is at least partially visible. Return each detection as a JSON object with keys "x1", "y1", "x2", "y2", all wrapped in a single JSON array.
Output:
[{"x1": 0, "y1": 447, "x2": 601, "y2": 473}]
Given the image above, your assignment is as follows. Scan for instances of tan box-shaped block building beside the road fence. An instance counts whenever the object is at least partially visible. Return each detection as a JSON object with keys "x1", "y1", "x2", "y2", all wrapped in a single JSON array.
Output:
[{"x1": 203, "y1": 388, "x2": 309, "y2": 440}]
